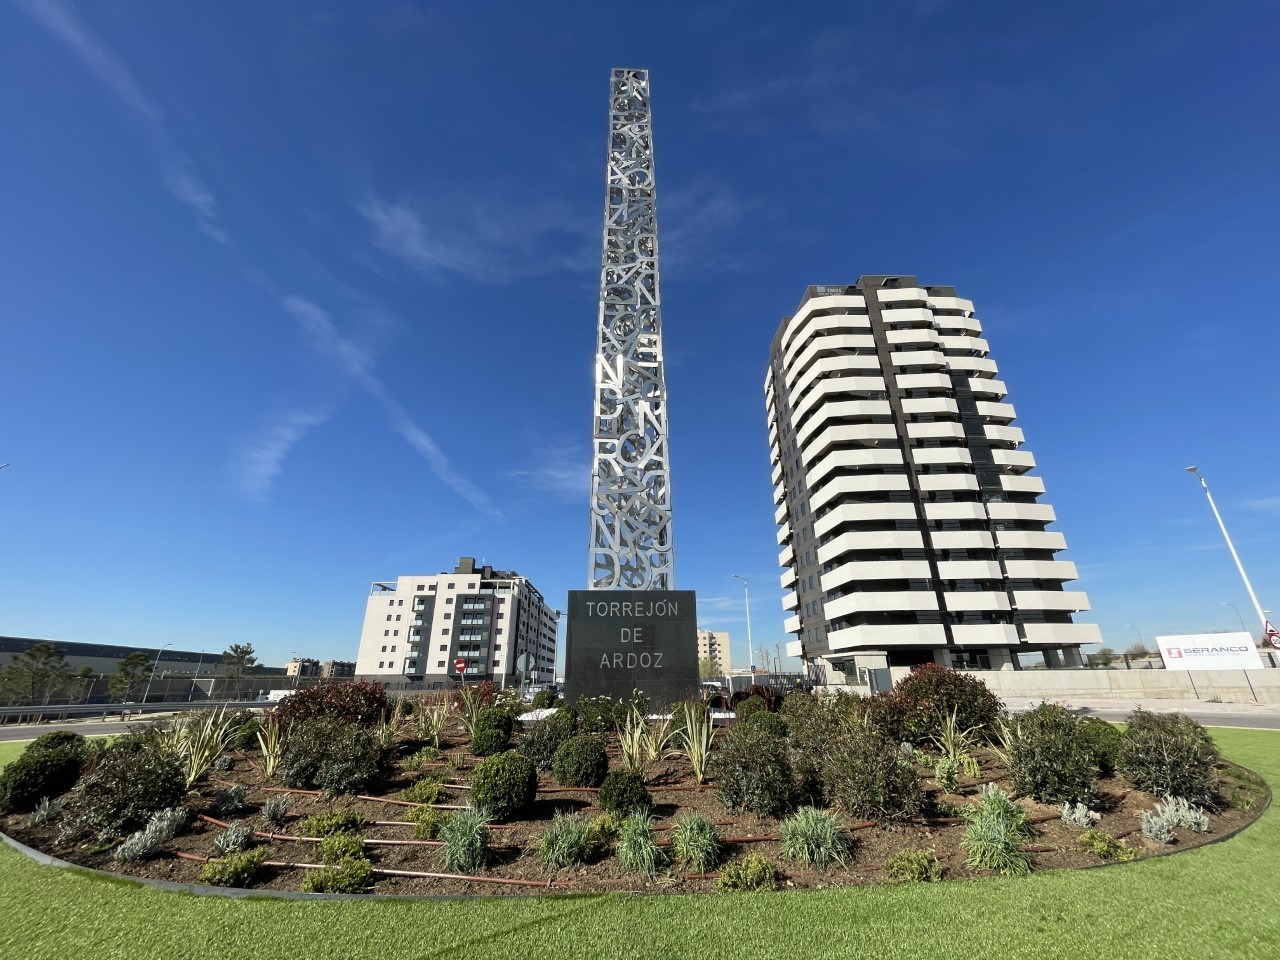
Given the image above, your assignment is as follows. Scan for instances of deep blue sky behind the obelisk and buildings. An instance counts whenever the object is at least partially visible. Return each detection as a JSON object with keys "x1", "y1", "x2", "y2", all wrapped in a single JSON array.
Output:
[{"x1": 0, "y1": 0, "x2": 1280, "y2": 663}]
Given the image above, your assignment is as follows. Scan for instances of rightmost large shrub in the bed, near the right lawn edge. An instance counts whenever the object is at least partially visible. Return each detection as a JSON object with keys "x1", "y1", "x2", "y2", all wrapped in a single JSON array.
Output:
[{"x1": 1116, "y1": 709, "x2": 1221, "y2": 804}]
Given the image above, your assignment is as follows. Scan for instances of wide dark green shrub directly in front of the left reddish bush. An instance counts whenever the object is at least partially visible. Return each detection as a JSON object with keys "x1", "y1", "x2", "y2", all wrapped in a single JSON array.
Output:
[{"x1": 280, "y1": 716, "x2": 387, "y2": 794}]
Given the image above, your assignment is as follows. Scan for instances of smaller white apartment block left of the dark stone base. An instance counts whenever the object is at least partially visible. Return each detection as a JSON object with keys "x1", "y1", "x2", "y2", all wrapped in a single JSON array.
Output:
[{"x1": 356, "y1": 557, "x2": 558, "y2": 690}]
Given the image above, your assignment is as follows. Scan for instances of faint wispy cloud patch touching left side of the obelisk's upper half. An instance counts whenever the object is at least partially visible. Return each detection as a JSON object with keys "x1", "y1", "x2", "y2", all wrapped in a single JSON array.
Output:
[{"x1": 356, "y1": 195, "x2": 599, "y2": 284}]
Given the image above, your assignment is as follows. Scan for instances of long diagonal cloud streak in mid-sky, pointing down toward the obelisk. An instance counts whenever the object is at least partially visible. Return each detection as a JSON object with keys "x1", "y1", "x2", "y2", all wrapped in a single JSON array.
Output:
[{"x1": 283, "y1": 296, "x2": 502, "y2": 517}]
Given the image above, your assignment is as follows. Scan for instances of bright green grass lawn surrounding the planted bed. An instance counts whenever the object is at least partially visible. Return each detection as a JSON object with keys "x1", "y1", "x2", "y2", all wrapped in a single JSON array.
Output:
[{"x1": 0, "y1": 728, "x2": 1280, "y2": 960}]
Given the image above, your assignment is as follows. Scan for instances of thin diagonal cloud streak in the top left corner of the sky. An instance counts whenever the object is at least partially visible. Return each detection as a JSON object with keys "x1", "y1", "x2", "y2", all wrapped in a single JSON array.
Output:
[{"x1": 15, "y1": 0, "x2": 229, "y2": 244}]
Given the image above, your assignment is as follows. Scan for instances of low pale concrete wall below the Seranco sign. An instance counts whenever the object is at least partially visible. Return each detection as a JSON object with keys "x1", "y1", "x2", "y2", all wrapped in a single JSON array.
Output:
[{"x1": 957, "y1": 669, "x2": 1280, "y2": 704}]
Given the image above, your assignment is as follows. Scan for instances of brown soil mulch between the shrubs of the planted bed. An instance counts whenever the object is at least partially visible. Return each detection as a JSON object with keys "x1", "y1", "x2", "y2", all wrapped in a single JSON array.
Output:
[{"x1": 0, "y1": 742, "x2": 1268, "y2": 896}]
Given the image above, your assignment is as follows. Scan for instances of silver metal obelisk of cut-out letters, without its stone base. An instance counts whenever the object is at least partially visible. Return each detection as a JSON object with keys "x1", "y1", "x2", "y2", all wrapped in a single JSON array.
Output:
[{"x1": 588, "y1": 69, "x2": 675, "y2": 590}]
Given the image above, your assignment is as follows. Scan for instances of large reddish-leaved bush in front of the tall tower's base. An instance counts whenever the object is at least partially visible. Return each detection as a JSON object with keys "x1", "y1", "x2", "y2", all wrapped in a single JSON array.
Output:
[{"x1": 870, "y1": 663, "x2": 1001, "y2": 744}]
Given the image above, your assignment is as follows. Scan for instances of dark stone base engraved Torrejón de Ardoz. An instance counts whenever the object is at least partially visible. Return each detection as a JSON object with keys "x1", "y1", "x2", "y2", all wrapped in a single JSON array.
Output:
[{"x1": 564, "y1": 590, "x2": 698, "y2": 707}]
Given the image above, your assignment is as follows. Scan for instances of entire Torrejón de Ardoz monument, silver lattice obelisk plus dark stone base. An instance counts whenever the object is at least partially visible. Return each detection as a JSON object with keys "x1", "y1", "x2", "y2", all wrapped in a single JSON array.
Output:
[{"x1": 564, "y1": 69, "x2": 698, "y2": 705}]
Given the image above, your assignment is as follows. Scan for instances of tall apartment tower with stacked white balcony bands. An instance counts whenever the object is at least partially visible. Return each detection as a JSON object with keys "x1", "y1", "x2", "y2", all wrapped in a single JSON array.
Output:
[{"x1": 764, "y1": 276, "x2": 1101, "y2": 682}]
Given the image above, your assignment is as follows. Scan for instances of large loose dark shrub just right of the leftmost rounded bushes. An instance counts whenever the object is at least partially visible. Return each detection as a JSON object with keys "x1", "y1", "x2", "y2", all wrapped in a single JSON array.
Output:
[{"x1": 76, "y1": 736, "x2": 187, "y2": 836}]
